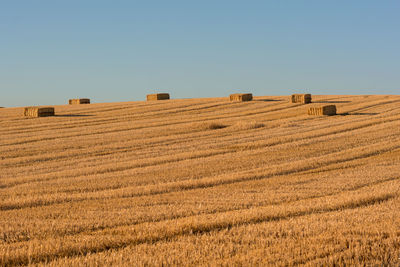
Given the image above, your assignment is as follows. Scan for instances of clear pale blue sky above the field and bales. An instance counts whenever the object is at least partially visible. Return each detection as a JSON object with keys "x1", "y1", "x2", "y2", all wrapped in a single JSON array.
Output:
[{"x1": 0, "y1": 0, "x2": 400, "y2": 106}]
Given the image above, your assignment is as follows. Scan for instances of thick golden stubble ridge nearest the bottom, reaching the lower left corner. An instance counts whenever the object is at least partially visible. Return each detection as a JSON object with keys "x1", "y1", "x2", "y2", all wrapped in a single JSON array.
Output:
[{"x1": 0, "y1": 181, "x2": 399, "y2": 265}]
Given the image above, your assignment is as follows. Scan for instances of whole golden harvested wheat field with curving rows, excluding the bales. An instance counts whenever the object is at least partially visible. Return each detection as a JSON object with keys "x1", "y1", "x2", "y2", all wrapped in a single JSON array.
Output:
[{"x1": 0, "y1": 95, "x2": 400, "y2": 266}]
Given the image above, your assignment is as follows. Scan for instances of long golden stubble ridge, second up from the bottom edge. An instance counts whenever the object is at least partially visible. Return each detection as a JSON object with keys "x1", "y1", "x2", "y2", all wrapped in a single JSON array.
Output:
[{"x1": 0, "y1": 136, "x2": 400, "y2": 210}]
